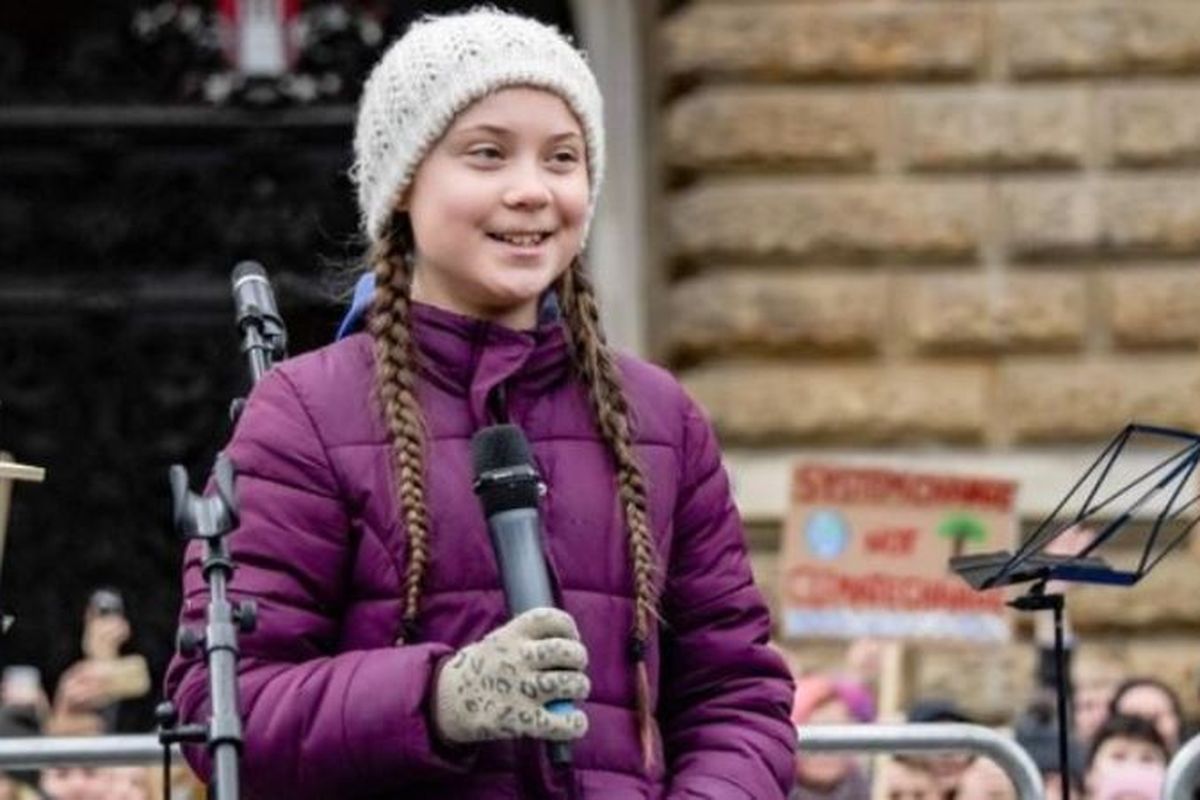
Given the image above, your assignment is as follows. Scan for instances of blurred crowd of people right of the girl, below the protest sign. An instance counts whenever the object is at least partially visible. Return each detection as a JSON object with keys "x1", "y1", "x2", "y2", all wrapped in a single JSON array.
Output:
[{"x1": 791, "y1": 528, "x2": 1189, "y2": 800}]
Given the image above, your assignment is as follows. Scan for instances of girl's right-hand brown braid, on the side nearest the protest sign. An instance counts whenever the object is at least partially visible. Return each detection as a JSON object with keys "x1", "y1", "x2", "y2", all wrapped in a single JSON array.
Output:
[{"x1": 562, "y1": 258, "x2": 659, "y2": 770}]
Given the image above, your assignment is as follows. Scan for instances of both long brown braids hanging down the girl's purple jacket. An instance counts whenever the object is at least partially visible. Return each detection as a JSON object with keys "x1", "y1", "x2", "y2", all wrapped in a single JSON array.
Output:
[{"x1": 370, "y1": 212, "x2": 659, "y2": 769}]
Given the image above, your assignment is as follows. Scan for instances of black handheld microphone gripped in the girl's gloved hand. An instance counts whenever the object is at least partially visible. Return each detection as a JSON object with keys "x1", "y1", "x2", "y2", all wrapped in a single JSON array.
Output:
[{"x1": 470, "y1": 425, "x2": 574, "y2": 766}]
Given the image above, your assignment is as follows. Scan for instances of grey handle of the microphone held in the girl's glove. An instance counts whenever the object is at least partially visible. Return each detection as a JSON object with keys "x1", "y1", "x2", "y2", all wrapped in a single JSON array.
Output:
[{"x1": 487, "y1": 509, "x2": 575, "y2": 766}]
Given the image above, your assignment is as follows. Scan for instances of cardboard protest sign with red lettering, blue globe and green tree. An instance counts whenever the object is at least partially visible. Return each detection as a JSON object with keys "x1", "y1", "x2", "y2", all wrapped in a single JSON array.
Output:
[{"x1": 780, "y1": 463, "x2": 1016, "y2": 642}]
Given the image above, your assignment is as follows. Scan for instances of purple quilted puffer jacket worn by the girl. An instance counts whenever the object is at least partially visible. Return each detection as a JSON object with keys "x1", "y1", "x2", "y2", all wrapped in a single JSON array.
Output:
[{"x1": 167, "y1": 305, "x2": 794, "y2": 800}]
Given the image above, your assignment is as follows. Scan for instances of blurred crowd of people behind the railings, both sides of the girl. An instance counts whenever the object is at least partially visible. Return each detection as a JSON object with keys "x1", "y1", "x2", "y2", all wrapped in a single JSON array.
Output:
[{"x1": 0, "y1": 582, "x2": 1189, "y2": 800}]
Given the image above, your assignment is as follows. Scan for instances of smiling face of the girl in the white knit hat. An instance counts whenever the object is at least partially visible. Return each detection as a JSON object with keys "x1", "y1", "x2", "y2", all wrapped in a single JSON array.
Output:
[{"x1": 401, "y1": 88, "x2": 589, "y2": 329}]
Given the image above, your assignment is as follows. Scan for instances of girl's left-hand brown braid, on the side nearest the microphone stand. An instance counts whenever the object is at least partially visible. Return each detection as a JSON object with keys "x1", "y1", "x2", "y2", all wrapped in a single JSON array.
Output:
[{"x1": 371, "y1": 215, "x2": 430, "y2": 642}]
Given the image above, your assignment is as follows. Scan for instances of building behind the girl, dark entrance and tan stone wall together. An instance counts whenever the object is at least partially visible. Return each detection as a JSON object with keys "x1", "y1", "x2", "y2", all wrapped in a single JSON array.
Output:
[{"x1": 0, "y1": 0, "x2": 1200, "y2": 734}]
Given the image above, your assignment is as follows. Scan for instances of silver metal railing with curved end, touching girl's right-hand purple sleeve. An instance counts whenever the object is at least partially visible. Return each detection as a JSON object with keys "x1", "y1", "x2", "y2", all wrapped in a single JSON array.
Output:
[{"x1": 796, "y1": 722, "x2": 1051, "y2": 800}]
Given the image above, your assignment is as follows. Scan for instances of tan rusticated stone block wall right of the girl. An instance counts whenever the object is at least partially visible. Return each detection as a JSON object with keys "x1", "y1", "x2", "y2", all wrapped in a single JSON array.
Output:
[{"x1": 650, "y1": 0, "x2": 1200, "y2": 717}]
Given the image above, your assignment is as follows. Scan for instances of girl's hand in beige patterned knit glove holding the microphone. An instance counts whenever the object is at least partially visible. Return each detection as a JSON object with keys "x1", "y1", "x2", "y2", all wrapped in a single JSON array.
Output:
[{"x1": 433, "y1": 608, "x2": 592, "y2": 744}]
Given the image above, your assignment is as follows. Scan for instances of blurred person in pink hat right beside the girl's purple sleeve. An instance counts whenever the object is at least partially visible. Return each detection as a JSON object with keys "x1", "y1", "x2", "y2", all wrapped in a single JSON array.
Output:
[{"x1": 788, "y1": 675, "x2": 875, "y2": 800}]
